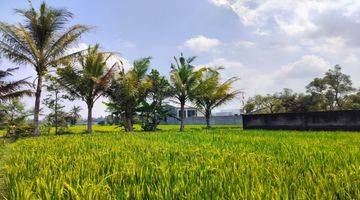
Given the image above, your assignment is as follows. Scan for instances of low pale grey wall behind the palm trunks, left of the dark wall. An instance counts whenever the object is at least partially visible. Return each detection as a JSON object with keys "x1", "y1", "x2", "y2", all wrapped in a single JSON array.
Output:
[{"x1": 162, "y1": 115, "x2": 242, "y2": 125}]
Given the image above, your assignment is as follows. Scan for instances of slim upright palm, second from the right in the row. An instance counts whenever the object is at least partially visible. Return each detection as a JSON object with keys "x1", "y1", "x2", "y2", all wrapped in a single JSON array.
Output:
[{"x1": 170, "y1": 54, "x2": 202, "y2": 131}]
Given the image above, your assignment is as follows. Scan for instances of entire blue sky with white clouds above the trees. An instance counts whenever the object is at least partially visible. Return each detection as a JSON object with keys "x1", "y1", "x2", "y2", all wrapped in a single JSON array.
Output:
[{"x1": 0, "y1": 0, "x2": 360, "y2": 117}]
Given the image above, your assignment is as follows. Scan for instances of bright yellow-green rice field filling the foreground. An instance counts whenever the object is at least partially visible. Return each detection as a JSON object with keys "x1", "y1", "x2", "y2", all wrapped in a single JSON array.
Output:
[{"x1": 0, "y1": 126, "x2": 360, "y2": 199}]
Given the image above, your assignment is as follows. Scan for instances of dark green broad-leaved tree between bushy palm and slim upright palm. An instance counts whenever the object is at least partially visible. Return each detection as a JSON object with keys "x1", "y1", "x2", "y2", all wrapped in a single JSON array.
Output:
[{"x1": 138, "y1": 69, "x2": 172, "y2": 131}]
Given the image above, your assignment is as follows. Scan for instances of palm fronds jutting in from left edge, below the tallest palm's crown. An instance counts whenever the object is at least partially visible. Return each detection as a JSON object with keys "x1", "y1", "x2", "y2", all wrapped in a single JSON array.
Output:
[{"x1": 0, "y1": 68, "x2": 32, "y2": 102}]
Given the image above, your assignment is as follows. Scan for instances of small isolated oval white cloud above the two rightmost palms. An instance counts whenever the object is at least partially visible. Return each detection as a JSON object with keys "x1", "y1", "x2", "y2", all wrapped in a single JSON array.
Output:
[{"x1": 182, "y1": 35, "x2": 221, "y2": 52}]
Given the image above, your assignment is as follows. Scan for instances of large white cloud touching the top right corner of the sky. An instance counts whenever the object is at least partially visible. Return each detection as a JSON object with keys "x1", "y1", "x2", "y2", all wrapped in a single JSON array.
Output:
[{"x1": 212, "y1": 0, "x2": 360, "y2": 36}]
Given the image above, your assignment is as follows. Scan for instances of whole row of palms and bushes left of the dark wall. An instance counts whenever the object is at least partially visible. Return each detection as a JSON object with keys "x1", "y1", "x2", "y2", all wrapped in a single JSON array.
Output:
[{"x1": 0, "y1": 1, "x2": 239, "y2": 136}]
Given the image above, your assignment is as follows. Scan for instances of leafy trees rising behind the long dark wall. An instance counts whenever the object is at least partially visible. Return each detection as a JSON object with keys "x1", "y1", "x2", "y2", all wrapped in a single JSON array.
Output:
[{"x1": 244, "y1": 65, "x2": 360, "y2": 113}]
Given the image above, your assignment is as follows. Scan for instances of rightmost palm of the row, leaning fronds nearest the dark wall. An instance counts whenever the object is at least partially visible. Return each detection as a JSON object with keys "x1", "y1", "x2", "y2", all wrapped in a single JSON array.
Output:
[{"x1": 193, "y1": 68, "x2": 241, "y2": 128}]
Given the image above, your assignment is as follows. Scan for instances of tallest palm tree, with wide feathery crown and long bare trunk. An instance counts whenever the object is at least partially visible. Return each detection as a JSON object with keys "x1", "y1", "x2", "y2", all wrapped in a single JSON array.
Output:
[{"x1": 0, "y1": 3, "x2": 89, "y2": 135}]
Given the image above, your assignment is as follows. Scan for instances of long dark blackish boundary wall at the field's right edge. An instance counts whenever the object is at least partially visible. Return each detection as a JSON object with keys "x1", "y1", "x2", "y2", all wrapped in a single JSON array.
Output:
[{"x1": 243, "y1": 110, "x2": 360, "y2": 131}]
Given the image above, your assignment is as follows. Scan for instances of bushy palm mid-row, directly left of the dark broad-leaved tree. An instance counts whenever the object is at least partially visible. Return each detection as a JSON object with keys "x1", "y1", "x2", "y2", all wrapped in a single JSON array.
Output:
[{"x1": 107, "y1": 57, "x2": 151, "y2": 131}]
